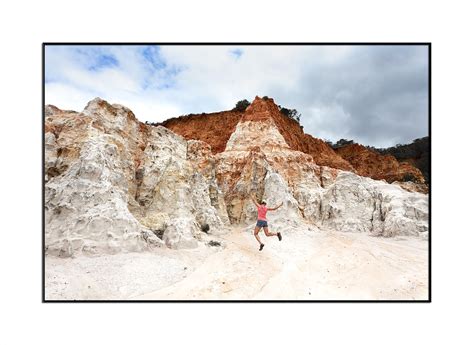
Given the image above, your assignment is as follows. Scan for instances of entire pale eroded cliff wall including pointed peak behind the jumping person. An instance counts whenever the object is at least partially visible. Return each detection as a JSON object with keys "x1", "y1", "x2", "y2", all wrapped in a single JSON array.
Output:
[{"x1": 45, "y1": 99, "x2": 428, "y2": 256}]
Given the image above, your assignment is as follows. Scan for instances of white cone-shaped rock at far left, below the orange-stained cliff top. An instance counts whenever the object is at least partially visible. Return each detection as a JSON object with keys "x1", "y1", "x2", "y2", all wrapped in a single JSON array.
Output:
[{"x1": 45, "y1": 123, "x2": 160, "y2": 256}]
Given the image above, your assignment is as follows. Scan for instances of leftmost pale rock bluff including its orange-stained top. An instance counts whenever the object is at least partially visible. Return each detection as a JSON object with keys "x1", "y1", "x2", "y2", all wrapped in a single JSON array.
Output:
[{"x1": 45, "y1": 100, "x2": 160, "y2": 256}]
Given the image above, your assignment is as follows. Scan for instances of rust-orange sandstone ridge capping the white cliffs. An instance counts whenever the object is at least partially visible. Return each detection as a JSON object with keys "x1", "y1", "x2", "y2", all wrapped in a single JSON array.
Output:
[{"x1": 160, "y1": 96, "x2": 427, "y2": 192}]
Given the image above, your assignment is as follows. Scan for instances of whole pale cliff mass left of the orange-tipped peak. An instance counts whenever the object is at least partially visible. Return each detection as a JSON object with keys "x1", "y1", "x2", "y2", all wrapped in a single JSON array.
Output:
[{"x1": 45, "y1": 99, "x2": 225, "y2": 256}]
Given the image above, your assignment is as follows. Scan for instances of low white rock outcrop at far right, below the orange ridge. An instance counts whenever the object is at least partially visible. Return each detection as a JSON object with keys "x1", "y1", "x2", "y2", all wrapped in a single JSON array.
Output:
[{"x1": 316, "y1": 172, "x2": 428, "y2": 237}]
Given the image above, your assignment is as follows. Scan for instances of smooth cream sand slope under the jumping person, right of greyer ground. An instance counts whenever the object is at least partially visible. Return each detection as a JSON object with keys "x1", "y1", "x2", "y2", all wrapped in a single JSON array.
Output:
[{"x1": 131, "y1": 224, "x2": 428, "y2": 299}]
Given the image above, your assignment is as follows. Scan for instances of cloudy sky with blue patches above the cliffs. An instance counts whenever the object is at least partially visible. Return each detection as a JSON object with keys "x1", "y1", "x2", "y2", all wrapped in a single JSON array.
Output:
[{"x1": 45, "y1": 45, "x2": 428, "y2": 147}]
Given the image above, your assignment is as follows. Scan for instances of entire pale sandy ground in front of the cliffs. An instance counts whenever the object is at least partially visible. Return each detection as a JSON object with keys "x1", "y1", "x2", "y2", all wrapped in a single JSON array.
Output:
[{"x1": 46, "y1": 227, "x2": 428, "y2": 300}]
